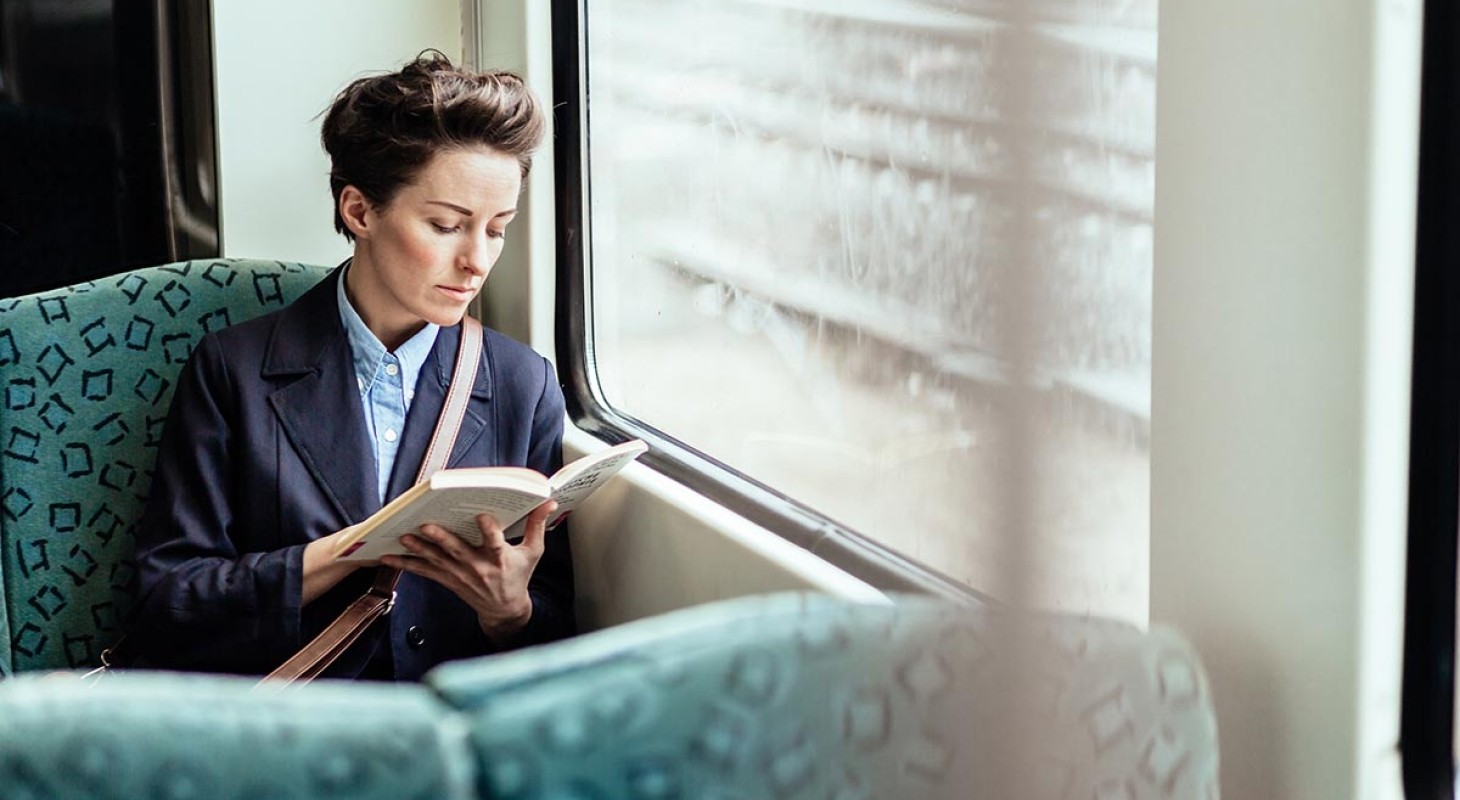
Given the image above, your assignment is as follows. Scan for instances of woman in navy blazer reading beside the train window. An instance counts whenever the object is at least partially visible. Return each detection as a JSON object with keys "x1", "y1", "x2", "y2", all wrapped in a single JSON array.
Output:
[{"x1": 131, "y1": 53, "x2": 574, "y2": 680}]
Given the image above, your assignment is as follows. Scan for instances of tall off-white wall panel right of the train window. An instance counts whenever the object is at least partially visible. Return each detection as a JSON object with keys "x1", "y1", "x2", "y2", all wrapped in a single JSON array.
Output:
[{"x1": 1150, "y1": 0, "x2": 1419, "y2": 800}]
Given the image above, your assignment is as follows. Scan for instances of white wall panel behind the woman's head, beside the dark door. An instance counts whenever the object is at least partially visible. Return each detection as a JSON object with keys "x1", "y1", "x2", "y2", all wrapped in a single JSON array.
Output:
[{"x1": 213, "y1": 0, "x2": 461, "y2": 264}]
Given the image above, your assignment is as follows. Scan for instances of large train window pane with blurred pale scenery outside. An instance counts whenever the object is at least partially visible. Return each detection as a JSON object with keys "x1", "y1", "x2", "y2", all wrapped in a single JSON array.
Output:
[{"x1": 558, "y1": 0, "x2": 1156, "y2": 619}]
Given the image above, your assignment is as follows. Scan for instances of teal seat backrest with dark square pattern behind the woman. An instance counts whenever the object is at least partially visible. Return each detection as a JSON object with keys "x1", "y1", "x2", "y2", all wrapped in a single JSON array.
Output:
[{"x1": 0, "y1": 260, "x2": 327, "y2": 676}]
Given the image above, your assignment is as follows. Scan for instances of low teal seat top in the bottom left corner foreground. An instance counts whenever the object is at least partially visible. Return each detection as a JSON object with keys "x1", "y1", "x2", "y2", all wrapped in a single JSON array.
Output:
[{"x1": 0, "y1": 672, "x2": 476, "y2": 800}]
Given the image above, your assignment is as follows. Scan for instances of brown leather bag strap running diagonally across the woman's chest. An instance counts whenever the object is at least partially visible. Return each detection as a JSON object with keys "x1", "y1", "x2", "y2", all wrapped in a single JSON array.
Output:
[{"x1": 263, "y1": 317, "x2": 482, "y2": 688}]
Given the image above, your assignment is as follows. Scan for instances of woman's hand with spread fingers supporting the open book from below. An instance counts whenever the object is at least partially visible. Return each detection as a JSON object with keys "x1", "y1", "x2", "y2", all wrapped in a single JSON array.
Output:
[{"x1": 381, "y1": 501, "x2": 558, "y2": 644}]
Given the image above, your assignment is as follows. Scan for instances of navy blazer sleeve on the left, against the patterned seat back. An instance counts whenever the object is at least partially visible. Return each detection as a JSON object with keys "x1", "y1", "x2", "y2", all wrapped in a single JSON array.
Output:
[{"x1": 130, "y1": 334, "x2": 304, "y2": 673}]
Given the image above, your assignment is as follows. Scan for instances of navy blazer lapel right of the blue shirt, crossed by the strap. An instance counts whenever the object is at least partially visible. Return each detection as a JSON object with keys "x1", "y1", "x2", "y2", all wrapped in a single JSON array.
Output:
[{"x1": 385, "y1": 326, "x2": 498, "y2": 499}]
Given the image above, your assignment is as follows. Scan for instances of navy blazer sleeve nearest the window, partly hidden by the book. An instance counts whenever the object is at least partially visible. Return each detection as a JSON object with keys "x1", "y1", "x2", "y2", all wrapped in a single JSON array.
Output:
[{"x1": 511, "y1": 359, "x2": 578, "y2": 647}]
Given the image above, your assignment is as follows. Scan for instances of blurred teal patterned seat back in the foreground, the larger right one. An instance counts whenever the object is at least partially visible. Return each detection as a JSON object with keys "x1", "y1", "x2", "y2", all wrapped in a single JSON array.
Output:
[{"x1": 426, "y1": 594, "x2": 1218, "y2": 800}]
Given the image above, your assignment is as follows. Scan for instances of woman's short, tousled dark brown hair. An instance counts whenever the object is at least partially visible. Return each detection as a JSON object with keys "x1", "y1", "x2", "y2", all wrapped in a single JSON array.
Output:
[{"x1": 320, "y1": 50, "x2": 546, "y2": 241}]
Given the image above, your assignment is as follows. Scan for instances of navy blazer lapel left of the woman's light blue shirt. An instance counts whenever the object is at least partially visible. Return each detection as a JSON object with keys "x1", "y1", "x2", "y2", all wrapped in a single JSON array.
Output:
[{"x1": 264, "y1": 270, "x2": 381, "y2": 524}]
